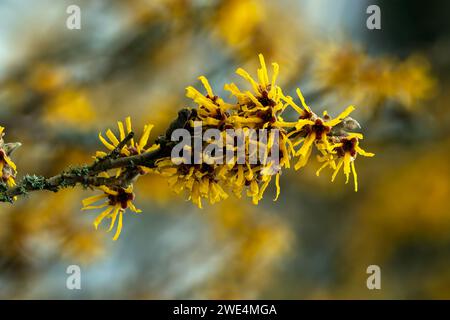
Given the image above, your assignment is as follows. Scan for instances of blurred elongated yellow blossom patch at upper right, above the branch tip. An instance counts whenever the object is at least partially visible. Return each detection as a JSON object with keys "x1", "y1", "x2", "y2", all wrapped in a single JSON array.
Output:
[{"x1": 313, "y1": 43, "x2": 436, "y2": 108}]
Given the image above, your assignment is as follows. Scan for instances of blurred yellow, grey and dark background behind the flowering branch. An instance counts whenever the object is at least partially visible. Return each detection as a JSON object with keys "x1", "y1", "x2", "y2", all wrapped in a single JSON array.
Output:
[{"x1": 0, "y1": 0, "x2": 450, "y2": 299}]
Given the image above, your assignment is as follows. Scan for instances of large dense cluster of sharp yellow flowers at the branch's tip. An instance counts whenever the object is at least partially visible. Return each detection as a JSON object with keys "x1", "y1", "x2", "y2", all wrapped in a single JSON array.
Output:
[{"x1": 156, "y1": 55, "x2": 373, "y2": 208}]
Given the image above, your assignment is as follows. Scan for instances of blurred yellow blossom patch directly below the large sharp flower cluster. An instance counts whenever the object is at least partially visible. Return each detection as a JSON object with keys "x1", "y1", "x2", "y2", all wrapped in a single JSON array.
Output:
[{"x1": 201, "y1": 198, "x2": 294, "y2": 299}]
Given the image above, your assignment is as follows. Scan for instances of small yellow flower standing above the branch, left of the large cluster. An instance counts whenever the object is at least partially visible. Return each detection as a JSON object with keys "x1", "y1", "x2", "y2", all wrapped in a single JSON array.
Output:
[{"x1": 95, "y1": 117, "x2": 159, "y2": 176}]
